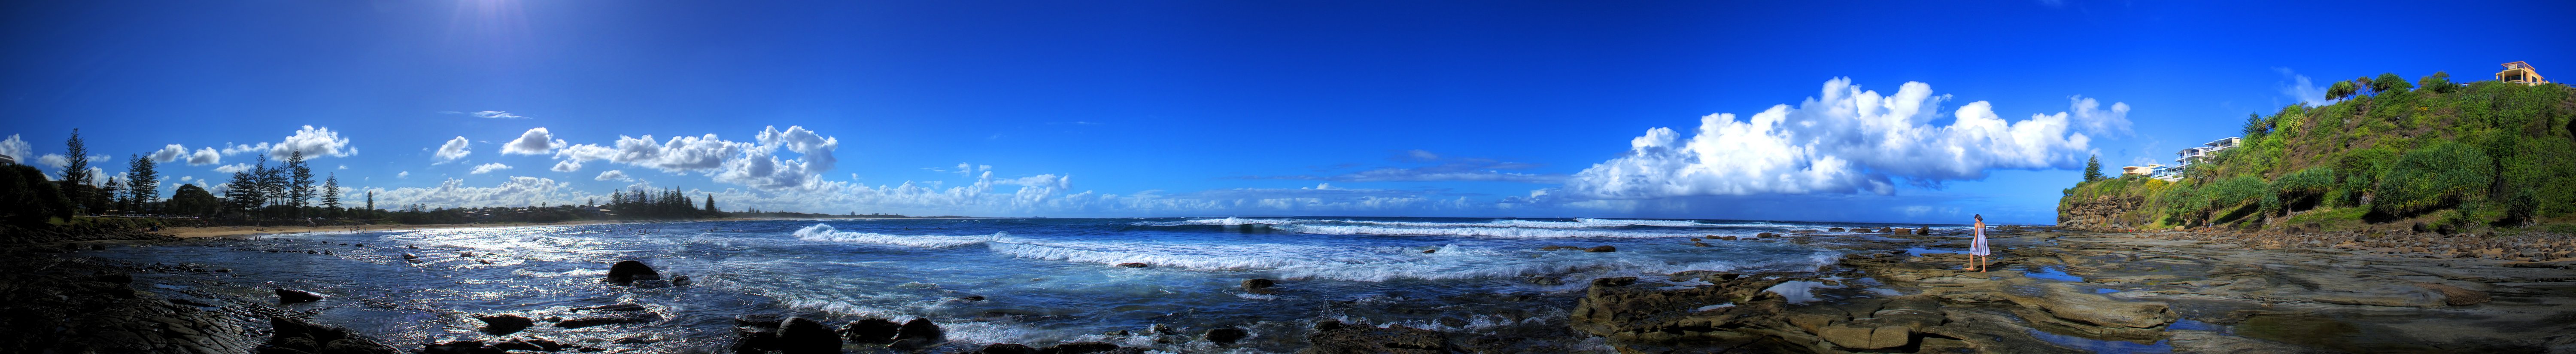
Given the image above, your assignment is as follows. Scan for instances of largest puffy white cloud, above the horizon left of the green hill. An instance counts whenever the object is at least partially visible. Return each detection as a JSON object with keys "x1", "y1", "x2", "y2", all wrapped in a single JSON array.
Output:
[{"x1": 1546, "y1": 77, "x2": 2128, "y2": 199}]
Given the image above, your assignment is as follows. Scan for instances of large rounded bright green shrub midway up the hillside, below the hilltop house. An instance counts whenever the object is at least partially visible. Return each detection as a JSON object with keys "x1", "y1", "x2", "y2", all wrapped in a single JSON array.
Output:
[{"x1": 2370, "y1": 142, "x2": 2496, "y2": 214}]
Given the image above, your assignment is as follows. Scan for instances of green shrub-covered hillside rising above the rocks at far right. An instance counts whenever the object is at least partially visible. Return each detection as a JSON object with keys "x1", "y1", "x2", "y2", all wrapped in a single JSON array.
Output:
[{"x1": 2058, "y1": 75, "x2": 2576, "y2": 232}]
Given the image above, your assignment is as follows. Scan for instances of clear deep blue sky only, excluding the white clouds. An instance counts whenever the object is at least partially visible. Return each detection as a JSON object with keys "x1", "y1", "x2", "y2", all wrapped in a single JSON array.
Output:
[{"x1": 0, "y1": 0, "x2": 2576, "y2": 222}]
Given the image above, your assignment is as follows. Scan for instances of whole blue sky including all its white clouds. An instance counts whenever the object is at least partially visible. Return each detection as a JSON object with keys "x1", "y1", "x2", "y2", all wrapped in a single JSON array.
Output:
[{"x1": 0, "y1": 0, "x2": 2576, "y2": 222}]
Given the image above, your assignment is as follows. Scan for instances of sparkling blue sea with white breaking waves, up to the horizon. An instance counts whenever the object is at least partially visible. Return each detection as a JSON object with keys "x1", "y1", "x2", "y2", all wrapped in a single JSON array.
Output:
[{"x1": 90, "y1": 217, "x2": 1937, "y2": 351}]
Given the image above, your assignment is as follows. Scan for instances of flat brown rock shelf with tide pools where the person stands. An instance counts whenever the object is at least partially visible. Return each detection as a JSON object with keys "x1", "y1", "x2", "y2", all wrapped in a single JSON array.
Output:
[{"x1": 1571, "y1": 230, "x2": 2576, "y2": 354}]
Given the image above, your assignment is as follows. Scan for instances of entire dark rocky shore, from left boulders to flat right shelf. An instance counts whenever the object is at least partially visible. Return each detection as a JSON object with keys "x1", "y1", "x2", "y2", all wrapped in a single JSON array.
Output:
[{"x1": 0, "y1": 227, "x2": 2576, "y2": 354}]
